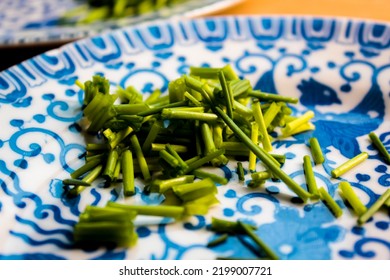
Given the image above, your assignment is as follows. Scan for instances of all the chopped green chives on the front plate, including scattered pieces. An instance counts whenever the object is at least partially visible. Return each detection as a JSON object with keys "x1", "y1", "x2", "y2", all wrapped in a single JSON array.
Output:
[{"x1": 63, "y1": 65, "x2": 390, "y2": 259}]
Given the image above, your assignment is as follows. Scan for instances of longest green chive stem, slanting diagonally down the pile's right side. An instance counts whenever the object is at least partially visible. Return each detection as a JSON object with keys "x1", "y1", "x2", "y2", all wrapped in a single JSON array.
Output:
[{"x1": 215, "y1": 107, "x2": 311, "y2": 202}]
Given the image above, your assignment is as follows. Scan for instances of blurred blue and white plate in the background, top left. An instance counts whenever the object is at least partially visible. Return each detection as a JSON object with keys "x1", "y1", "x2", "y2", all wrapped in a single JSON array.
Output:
[{"x1": 0, "y1": 0, "x2": 242, "y2": 47}]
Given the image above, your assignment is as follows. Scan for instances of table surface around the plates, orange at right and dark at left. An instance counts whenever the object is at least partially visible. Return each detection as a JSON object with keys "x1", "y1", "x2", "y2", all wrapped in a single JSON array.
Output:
[{"x1": 0, "y1": 0, "x2": 390, "y2": 71}]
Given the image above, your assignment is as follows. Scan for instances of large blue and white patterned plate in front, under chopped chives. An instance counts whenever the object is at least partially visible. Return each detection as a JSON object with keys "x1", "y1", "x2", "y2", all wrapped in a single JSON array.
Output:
[{"x1": 0, "y1": 16, "x2": 390, "y2": 259}]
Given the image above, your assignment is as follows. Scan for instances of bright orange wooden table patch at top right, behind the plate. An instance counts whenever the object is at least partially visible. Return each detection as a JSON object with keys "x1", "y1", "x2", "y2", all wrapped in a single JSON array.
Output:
[{"x1": 213, "y1": 0, "x2": 390, "y2": 21}]
